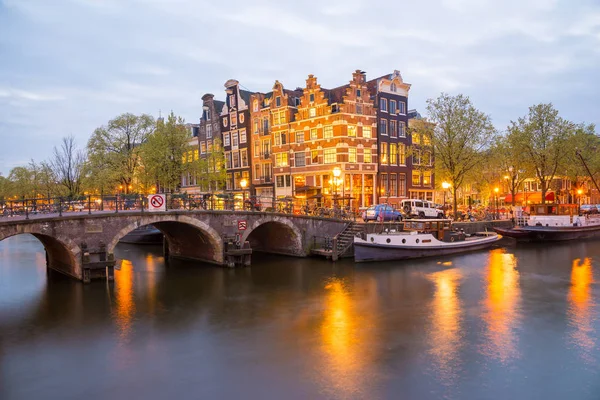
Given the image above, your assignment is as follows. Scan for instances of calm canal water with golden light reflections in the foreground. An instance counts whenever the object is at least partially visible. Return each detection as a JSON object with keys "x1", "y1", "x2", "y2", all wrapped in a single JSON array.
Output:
[{"x1": 0, "y1": 235, "x2": 600, "y2": 400}]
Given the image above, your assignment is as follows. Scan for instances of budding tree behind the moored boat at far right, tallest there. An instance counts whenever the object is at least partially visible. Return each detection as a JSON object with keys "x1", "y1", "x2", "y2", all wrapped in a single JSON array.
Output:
[{"x1": 508, "y1": 103, "x2": 575, "y2": 204}]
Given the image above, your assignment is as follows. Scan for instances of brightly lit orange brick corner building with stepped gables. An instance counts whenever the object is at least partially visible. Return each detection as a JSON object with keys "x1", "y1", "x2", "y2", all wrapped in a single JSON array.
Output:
[{"x1": 282, "y1": 70, "x2": 377, "y2": 208}]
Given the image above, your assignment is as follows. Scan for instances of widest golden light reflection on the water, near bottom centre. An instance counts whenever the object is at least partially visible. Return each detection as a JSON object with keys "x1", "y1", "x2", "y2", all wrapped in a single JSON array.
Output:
[{"x1": 321, "y1": 278, "x2": 367, "y2": 398}]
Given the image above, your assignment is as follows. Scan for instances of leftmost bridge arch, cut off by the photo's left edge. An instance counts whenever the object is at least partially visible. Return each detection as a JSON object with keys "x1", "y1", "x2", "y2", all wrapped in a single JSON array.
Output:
[{"x1": 0, "y1": 228, "x2": 83, "y2": 280}]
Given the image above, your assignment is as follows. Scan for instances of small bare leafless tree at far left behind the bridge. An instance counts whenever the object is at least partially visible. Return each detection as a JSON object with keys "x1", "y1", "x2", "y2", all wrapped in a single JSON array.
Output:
[{"x1": 50, "y1": 136, "x2": 86, "y2": 197}]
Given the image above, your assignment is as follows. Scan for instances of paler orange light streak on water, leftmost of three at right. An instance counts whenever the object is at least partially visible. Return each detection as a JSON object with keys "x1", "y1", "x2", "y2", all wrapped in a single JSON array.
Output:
[{"x1": 428, "y1": 269, "x2": 463, "y2": 385}]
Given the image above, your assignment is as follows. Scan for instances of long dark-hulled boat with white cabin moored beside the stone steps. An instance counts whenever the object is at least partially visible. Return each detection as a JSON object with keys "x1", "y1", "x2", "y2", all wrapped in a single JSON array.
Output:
[{"x1": 354, "y1": 219, "x2": 502, "y2": 262}]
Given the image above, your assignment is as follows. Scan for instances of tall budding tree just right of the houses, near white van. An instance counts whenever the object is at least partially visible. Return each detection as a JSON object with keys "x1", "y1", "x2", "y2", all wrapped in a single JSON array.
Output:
[{"x1": 427, "y1": 93, "x2": 496, "y2": 217}]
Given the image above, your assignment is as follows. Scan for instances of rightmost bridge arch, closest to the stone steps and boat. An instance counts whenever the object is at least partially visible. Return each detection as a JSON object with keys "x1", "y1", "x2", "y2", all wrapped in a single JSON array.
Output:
[{"x1": 241, "y1": 216, "x2": 306, "y2": 256}]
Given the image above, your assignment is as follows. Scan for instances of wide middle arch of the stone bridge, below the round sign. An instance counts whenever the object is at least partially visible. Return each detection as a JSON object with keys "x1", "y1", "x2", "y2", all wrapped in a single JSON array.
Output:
[{"x1": 107, "y1": 215, "x2": 223, "y2": 264}]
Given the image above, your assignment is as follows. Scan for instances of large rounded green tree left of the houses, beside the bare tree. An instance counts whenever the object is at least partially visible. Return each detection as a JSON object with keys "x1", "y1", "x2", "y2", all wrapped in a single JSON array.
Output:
[{"x1": 87, "y1": 113, "x2": 155, "y2": 193}]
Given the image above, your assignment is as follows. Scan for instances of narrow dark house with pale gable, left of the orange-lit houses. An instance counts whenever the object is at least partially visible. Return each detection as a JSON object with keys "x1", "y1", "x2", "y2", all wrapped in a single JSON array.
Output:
[{"x1": 220, "y1": 79, "x2": 252, "y2": 198}]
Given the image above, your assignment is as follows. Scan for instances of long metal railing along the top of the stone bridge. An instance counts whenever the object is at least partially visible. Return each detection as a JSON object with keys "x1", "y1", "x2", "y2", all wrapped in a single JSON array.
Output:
[{"x1": 0, "y1": 193, "x2": 358, "y2": 220}]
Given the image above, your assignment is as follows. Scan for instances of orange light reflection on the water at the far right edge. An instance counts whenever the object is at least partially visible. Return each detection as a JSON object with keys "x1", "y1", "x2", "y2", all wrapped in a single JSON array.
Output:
[{"x1": 568, "y1": 258, "x2": 596, "y2": 364}]
